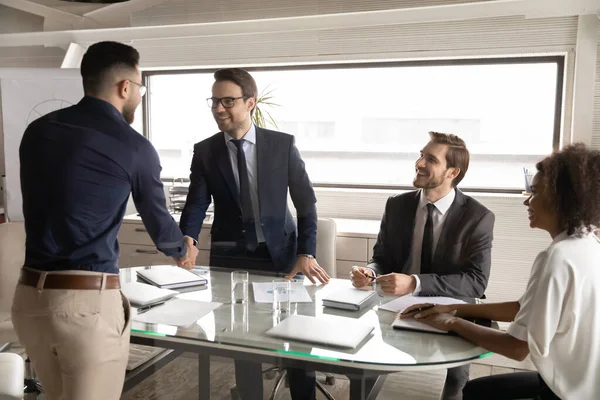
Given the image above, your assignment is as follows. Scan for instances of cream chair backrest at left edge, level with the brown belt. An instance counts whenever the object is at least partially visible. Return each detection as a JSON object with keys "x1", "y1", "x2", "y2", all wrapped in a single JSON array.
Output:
[{"x1": 0, "y1": 222, "x2": 25, "y2": 312}]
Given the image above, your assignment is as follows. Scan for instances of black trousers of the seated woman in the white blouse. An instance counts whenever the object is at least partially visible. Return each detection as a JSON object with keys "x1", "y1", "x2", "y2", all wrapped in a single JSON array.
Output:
[{"x1": 463, "y1": 372, "x2": 560, "y2": 400}]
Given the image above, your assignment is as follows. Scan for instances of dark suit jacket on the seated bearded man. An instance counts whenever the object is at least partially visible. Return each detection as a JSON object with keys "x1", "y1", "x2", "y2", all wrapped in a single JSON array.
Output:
[{"x1": 369, "y1": 189, "x2": 495, "y2": 298}]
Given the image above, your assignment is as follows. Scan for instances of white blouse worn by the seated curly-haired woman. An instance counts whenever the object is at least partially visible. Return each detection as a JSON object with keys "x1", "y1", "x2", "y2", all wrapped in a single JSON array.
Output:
[{"x1": 507, "y1": 232, "x2": 600, "y2": 400}]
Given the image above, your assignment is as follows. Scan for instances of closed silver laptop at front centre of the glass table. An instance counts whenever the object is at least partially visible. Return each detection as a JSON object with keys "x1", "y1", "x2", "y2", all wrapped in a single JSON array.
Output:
[{"x1": 266, "y1": 315, "x2": 373, "y2": 349}]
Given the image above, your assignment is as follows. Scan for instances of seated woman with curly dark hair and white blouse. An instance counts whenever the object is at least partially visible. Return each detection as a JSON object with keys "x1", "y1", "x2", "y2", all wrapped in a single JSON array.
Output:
[{"x1": 401, "y1": 144, "x2": 600, "y2": 400}]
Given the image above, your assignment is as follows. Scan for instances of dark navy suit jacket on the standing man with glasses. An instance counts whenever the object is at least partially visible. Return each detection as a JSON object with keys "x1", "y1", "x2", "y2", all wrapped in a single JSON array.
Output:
[{"x1": 180, "y1": 127, "x2": 317, "y2": 272}]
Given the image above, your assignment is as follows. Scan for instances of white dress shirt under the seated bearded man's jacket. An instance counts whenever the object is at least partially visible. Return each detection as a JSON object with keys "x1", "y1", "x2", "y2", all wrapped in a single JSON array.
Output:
[{"x1": 410, "y1": 189, "x2": 456, "y2": 295}]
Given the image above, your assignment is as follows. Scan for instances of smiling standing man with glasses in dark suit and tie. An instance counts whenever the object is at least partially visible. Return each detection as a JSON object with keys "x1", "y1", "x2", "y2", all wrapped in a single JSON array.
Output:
[{"x1": 180, "y1": 68, "x2": 329, "y2": 400}]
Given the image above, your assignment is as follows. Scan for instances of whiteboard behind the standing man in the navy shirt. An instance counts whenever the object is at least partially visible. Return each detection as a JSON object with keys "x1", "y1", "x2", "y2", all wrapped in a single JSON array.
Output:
[{"x1": 0, "y1": 68, "x2": 83, "y2": 221}]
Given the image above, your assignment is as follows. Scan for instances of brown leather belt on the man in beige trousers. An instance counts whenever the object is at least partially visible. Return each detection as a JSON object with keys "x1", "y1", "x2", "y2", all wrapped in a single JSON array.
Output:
[{"x1": 19, "y1": 269, "x2": 121, "y2": 290}]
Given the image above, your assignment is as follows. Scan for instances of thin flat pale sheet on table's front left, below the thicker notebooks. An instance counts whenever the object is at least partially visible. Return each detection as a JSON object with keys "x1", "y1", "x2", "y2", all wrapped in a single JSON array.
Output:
[{"x1": 133, "y1": 298, "x2": 222, "y2": 326}]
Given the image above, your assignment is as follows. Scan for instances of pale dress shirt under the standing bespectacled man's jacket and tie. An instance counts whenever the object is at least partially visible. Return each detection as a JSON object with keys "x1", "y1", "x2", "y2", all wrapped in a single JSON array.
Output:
[{"x1": 224, "y1": 124, "x2": 265, "y2": 243}]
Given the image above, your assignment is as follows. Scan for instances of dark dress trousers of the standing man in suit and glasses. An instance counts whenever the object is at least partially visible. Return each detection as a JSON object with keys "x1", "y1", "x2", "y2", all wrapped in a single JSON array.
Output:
[{"x1": 210, "y1": 242, "x2": 316, "y2": 400}]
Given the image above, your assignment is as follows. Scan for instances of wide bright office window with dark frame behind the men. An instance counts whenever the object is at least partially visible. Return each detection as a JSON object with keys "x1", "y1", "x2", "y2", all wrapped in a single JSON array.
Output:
[{"x1": 146, "y1": 57, "x2": 563, "y2": 190}]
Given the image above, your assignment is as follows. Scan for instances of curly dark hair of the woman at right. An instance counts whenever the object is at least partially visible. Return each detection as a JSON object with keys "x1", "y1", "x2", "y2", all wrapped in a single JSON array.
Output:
[{"x1": 536, "y1": 143, "x2": 600, "y2": 235}]
